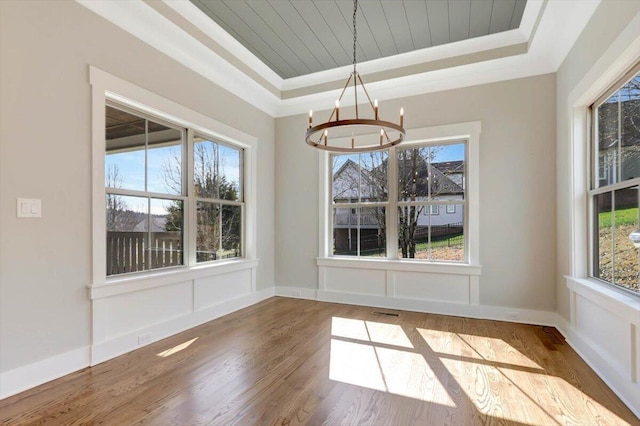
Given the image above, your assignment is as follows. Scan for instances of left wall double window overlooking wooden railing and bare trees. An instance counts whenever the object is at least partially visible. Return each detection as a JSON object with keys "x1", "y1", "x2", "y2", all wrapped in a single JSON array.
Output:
[{"x1": 104, "y1": 103, "x2": 244, "y2": 276}]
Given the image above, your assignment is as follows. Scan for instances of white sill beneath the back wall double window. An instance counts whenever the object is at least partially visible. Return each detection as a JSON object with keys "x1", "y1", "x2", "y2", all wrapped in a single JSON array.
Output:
[{"x1": 316, "y1": 257, "x2": 482, "y2": 276}]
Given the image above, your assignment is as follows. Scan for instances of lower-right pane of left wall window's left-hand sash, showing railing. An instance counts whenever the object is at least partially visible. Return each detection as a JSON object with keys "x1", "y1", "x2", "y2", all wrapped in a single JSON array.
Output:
[{"x1": 149, "y1": 198, "x2": 184, "y2": 269}]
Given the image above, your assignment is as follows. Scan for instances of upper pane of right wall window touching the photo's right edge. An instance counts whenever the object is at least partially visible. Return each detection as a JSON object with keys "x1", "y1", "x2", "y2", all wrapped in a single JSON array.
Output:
[{"x1": 620, "y1": 74, "x2": 640, "y2": 180}]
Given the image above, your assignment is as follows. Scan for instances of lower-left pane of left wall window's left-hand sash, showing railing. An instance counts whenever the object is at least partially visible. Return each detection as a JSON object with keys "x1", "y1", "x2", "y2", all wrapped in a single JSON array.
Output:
[{"x1": 106, "y1": 194, "x2": 149, "y2": 275}]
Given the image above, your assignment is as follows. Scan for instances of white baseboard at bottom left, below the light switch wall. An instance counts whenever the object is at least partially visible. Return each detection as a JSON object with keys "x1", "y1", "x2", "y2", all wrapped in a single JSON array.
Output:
[{"x1": 0, "y1": 346, "x2": 90, "y2": 399}]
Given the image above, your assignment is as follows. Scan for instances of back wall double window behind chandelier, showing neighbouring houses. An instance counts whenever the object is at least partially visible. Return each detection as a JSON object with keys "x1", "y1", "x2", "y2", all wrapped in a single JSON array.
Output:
[{"x1": 329, "y1": 139, "x2": 469, "y2": 262}]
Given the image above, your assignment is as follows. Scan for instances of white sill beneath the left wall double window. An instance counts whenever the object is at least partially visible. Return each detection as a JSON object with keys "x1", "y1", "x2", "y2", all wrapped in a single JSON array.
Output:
[{"x1": 89, "y1": 259, "x2": 258, "y2": 300}]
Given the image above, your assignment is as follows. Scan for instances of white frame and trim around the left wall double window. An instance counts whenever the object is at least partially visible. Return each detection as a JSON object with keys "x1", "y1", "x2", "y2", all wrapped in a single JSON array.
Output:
[{"x1": 89, "y1": 66, "x2": 257, "y2": 294}]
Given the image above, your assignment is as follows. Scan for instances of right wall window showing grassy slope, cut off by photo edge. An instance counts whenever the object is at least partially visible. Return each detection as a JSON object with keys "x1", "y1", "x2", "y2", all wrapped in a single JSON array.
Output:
[{"x1": 589, "y1": 64, "x2": 640, "y2": 294}]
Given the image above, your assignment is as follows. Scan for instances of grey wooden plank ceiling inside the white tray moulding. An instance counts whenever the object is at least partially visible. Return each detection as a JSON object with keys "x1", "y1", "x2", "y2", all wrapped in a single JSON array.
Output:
[{"x1": 191, "y1": 0, "x2": 526, "y2": 78}]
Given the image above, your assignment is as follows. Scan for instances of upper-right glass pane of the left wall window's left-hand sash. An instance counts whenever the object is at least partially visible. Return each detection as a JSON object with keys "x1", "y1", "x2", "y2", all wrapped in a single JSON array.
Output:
[{"x1": 147, "y1": 121, "x2": 182, "y2": 195}]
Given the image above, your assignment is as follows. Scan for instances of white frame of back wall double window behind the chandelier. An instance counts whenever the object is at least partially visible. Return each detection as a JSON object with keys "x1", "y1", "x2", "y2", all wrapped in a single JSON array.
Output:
[{"x1": 318, "y1": 121, "x2": 481, "y2": 271}]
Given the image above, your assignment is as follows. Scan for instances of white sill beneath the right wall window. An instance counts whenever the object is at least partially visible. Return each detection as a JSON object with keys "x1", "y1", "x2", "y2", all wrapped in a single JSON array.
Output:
[{"x1": 565, "y1": 276, "x2": 640, "y2": 324}]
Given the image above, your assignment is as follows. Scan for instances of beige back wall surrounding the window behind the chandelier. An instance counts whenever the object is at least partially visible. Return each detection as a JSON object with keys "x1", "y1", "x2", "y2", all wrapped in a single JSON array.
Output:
[{"x1": 276, "y1": 74, "x2": 556, "y2": 311}]
